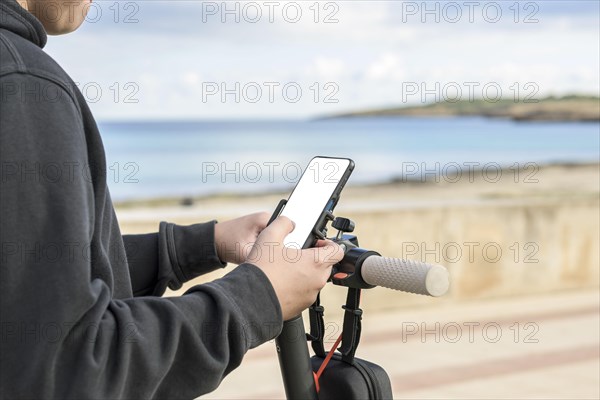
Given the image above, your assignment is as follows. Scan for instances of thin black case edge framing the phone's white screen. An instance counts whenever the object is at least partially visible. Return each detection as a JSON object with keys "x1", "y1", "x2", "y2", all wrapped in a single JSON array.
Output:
[{"x1": 268, "y1": 156, "x2": 354, "y2": 249}]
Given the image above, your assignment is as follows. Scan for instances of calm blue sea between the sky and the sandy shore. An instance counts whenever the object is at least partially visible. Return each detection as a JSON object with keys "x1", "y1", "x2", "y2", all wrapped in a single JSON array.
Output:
[{"x1": 99, "y1": 117, "x2": 600, "y2": 201}]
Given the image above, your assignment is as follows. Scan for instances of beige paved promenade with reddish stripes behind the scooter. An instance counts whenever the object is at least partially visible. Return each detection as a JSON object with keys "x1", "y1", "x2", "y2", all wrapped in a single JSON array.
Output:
[{"x1": 199, "y1": 290, "x2": 600, "y2": 399}]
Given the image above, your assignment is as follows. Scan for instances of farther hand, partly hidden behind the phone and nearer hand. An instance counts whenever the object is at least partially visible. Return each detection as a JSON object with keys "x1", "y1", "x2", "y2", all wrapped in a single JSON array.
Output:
[{"x1": 215, "y1": 212, "x2": 271, "y2": 264}]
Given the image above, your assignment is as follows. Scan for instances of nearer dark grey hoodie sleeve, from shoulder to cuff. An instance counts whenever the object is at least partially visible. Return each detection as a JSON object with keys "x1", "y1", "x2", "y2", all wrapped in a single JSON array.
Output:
[{"x1": 0, "y1": 73, "x2": 282, "y2": 399}]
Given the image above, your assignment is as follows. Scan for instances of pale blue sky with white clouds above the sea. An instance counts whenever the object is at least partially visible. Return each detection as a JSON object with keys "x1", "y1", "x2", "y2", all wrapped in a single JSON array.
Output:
[{"x1": 46, "y1": 0, "x2": 600, "y2": 121}]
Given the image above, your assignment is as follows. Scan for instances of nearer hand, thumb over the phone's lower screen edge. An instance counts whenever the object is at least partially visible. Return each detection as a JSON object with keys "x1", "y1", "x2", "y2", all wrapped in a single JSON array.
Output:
[{"x1": 246, "y1": 217, "x2": 344, "y2": 321}]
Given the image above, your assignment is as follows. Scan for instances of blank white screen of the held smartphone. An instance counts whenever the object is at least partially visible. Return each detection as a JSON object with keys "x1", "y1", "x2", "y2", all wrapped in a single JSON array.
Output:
[{"x1": 281, "y1": 157, "x2": 350, "y2": 249}]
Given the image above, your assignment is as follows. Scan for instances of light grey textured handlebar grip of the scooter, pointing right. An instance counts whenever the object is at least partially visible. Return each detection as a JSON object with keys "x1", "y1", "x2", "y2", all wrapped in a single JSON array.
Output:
[{"x1": 361, "y1": 256, "x2": 450, "y2": 297}]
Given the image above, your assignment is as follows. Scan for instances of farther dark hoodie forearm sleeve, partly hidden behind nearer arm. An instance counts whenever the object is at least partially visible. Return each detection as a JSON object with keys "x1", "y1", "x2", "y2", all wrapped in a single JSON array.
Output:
[{"x1": 123, "y1": 221, "x2": 227, "y2": 296}]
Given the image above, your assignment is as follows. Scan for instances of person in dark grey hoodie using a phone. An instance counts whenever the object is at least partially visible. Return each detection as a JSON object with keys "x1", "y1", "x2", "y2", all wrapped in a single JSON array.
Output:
[{"x1": 0, "y1": 0, "x2": 342, "y2": 399}]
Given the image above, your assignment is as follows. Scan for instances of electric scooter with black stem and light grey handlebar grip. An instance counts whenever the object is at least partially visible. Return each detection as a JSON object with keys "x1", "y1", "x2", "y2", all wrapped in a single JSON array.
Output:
[{"x1": 275, "y1": 211, "x2": 450, "y2": 400}]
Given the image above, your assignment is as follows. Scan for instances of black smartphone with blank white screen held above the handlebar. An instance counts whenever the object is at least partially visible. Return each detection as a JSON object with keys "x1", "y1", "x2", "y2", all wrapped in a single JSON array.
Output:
[{"x1": 280, "y1": 156, "x2": 354, "y2": 249}]
